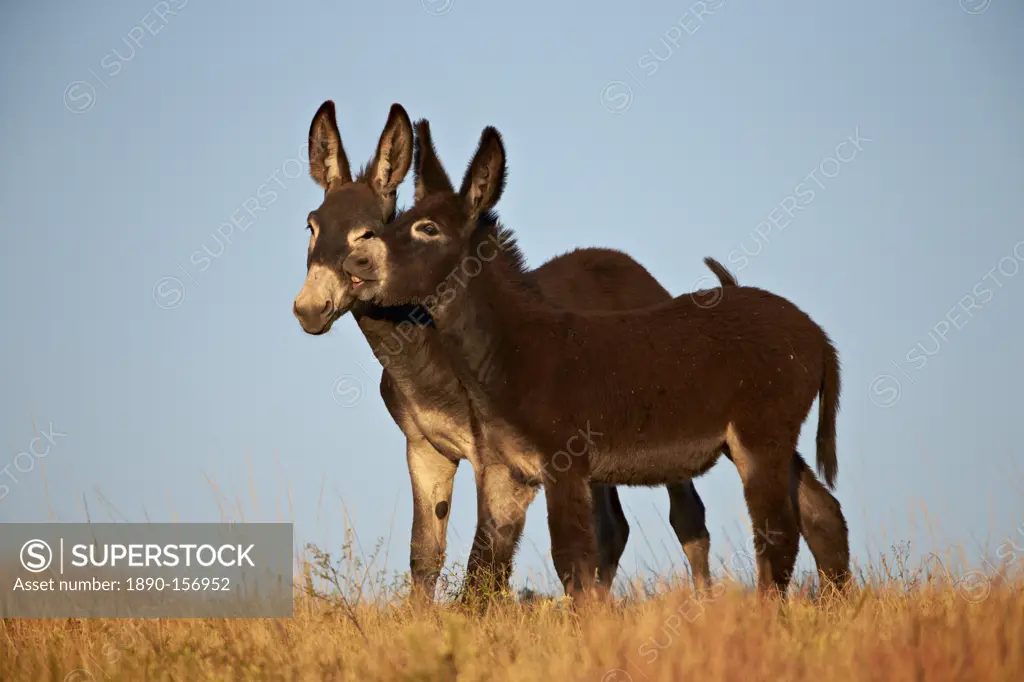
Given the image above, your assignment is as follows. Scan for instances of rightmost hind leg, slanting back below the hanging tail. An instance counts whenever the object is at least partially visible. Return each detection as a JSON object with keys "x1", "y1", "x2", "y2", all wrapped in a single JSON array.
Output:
[{"x1": 791, "y1": 453, "x2": 850, "y2": 591}]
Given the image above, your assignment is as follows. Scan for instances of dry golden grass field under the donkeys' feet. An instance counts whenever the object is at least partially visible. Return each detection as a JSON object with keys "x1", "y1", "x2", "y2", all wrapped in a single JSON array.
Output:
[{"x1": 0, "y1": 540, "x2": 1024, "y2": 682}]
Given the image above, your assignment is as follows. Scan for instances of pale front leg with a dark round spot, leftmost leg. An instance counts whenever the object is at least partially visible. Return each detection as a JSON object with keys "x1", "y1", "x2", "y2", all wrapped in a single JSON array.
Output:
[{"x1": 406, "y1": 435, "x2": 458, "y2": 600}]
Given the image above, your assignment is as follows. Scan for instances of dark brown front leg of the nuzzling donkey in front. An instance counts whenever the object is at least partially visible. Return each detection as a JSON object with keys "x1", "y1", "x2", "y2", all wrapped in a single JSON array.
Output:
[{"x1": 544, "y1": 470, "x2": 607, "y2": 601}]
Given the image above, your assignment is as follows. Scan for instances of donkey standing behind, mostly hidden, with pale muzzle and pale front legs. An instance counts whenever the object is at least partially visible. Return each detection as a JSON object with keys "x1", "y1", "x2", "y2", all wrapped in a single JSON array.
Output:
[{"x1": 294, "y1": 100, "x2": 734, "y2": 595}]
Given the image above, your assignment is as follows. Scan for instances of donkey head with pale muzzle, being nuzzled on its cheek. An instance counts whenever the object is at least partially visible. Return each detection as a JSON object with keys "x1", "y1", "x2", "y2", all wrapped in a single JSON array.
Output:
[{"x1": 292, "y1": 99, "x2": 413, "y2": 335}]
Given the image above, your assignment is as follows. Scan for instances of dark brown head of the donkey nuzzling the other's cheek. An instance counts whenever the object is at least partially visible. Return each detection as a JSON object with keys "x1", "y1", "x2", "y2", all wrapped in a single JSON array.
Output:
[{"x1": 345, "y1": 121, "x2": 506, "y2": 305}]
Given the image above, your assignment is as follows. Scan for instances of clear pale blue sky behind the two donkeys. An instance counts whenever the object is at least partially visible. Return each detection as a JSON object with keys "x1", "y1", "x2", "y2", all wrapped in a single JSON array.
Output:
[{"x1": 0, "y1": 0, "x2": 1024, "y2": 582}]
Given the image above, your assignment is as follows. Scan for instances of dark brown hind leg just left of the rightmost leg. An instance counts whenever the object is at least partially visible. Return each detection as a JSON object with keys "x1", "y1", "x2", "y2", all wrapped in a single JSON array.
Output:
[{"x1": 725, "y1": 425, "x2": 800, "y2": 596}]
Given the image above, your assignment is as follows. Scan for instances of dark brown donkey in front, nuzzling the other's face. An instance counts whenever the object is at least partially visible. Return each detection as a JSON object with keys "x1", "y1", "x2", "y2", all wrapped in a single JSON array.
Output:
[{"x1": 345, "y1": 122, "x2": 849, "y2": 594}]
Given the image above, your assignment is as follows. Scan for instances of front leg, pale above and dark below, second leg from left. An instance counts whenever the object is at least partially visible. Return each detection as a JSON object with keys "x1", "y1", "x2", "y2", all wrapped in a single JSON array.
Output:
[{"x1": 463, "y1": 464, "x2": 537, "y2": 600}]
